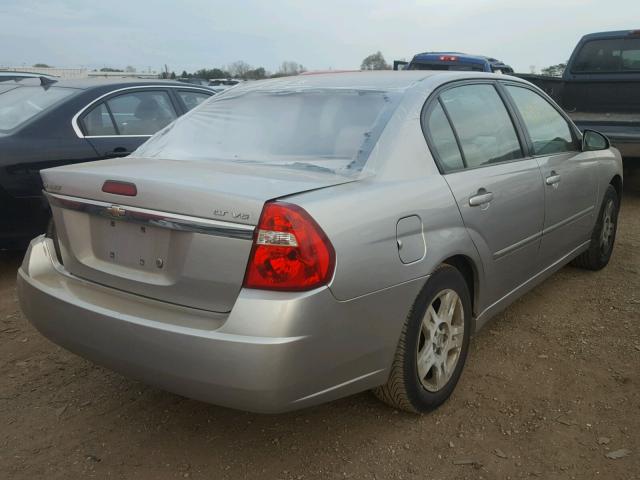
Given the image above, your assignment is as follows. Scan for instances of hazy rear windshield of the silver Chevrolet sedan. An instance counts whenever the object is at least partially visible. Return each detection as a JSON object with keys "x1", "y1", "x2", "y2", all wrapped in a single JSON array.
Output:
[{"x1": 136, "y1": 88, "x2": 399, "y2": 171}]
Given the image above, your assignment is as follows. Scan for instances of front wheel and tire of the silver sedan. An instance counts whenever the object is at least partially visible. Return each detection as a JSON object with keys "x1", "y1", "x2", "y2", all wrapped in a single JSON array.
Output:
[{"x1": 571, "y1": 185, "x2": 620, "y2": 270}]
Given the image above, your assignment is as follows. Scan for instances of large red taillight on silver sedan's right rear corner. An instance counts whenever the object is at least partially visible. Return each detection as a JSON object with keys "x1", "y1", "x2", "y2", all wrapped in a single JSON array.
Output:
[{"x1": 244, "y1": 202, "x2": 335, "y2": 291}]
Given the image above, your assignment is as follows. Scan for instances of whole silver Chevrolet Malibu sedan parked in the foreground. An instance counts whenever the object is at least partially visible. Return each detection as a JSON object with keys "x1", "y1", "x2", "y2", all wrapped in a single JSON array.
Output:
[{"x1": 18, "y1": 71, "x2": 622, "y2": 412}]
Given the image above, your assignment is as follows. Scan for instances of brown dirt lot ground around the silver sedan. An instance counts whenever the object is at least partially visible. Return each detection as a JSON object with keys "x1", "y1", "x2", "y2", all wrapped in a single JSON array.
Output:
[{"x1": 0, "y1": 175, "x2": 640, "y2": 479}]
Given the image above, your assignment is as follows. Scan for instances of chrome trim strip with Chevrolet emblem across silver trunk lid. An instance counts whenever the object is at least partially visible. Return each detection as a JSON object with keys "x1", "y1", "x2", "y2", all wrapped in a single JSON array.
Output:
[{"x1": 44, "y1": 191, "x2": 255, "y2": 240}]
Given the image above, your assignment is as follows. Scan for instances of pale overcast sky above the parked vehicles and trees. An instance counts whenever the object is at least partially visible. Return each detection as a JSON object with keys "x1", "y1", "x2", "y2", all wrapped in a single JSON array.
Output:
[{"x1": 0, "y1": 0, "x2": 640, "y2": 73}]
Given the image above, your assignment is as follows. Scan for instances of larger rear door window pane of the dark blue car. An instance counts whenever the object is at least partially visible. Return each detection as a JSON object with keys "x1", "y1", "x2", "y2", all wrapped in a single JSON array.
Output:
[{"x1": 107, "y1": 91, "x2": 177, "y2": 135}]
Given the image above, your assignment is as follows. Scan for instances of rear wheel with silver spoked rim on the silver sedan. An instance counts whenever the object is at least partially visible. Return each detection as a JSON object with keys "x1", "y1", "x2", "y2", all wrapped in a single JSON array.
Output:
[{"x1": 373, "y1": 265, "x2": 471, "y2": 413}]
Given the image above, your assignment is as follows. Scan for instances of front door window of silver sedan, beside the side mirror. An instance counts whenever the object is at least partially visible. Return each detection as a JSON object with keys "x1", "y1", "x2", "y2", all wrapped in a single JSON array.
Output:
[{"x1": 505, "y1": 85, "x2": 576, "y2": 155}]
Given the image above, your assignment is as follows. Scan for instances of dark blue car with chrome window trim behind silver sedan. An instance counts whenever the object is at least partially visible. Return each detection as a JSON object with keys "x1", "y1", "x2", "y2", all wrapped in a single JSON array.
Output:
[{"x1": 0, "y1": 77, "x2": 214, "y2": 250}]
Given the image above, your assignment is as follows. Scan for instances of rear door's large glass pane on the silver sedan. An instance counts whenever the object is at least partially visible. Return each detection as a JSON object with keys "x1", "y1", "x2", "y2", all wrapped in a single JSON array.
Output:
[{"x1": 440, "y1": 84, "x2": 523, "y2": 168}]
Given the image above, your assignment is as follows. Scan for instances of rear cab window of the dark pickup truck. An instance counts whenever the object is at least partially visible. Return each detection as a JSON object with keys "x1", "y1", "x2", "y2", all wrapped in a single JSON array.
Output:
[{"x1": 571, "y1": 38, "x2": 640, "y2": 73}]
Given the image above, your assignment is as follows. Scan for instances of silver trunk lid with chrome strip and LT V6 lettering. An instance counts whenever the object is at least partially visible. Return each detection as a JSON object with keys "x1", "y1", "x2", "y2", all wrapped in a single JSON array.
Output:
[{"x1": 41, "y1": 157, "x2": 354, "y2": 312}]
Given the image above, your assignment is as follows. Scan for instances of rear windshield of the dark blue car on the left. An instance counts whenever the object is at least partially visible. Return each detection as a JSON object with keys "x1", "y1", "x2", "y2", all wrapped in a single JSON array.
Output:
[{"x1": 0, "y1": 85, "x2": 75, "y2": 132}]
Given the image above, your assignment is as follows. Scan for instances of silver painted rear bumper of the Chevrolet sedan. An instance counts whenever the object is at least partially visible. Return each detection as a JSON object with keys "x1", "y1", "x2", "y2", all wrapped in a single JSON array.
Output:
[{"x1": 18, "y1": 236, "x2": 425, "y2": 413}]
